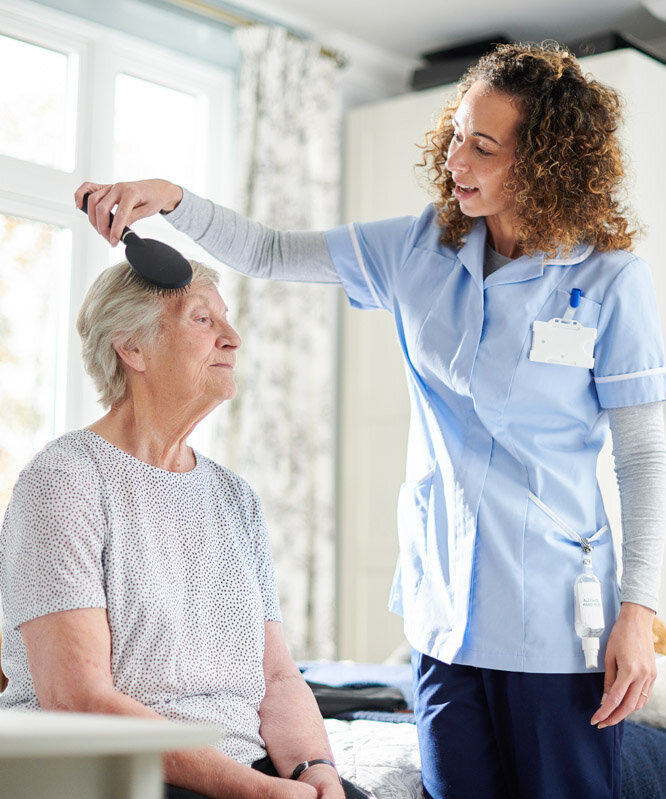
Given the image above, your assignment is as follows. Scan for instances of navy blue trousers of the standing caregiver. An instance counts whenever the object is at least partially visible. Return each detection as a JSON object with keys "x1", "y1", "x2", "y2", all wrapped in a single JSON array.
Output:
[{"x1": 412, "y1": 652, "x2": 623, "y2": 799}]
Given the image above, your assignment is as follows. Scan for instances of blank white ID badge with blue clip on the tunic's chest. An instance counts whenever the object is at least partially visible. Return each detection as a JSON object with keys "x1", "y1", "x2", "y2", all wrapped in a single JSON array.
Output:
[{"x1": 530, "y1": 289, "x2": 597, "y2": 369}]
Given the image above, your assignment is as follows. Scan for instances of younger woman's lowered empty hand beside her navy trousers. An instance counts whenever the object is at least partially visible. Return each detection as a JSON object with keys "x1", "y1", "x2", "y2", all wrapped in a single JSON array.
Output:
[{"x1": 591, "y1": 602, "x2": 657, "y2": 729}]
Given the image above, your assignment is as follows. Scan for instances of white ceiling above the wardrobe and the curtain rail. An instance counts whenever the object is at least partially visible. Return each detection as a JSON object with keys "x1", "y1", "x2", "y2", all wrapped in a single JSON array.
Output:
[{"x1": 231, "y1": 0, "x2": 666, "y2": 59}]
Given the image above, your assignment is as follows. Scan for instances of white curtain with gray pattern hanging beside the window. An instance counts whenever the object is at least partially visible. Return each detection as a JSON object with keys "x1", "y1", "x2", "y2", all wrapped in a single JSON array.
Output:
[{"x1": 209, "y1": 26, "x2": 341, "y2": 658}]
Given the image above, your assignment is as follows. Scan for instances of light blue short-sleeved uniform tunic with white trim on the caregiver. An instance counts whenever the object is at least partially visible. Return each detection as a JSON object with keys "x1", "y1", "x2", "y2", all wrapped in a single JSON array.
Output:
[{"x1": 326, "y1": 206, "x2": 666, "y2": 673}]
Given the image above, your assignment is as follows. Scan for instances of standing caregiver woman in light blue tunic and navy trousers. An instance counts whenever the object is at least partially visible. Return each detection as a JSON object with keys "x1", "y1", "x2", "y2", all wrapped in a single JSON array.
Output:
[{"x1": 76, "y1": 44, "x2": 666, "y2": 799}]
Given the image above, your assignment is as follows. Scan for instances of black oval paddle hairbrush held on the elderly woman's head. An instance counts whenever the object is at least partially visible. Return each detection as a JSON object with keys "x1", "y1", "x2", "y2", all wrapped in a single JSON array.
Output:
[{"x1": 81, "y1": 194, "x2": 192, "y2": 296}]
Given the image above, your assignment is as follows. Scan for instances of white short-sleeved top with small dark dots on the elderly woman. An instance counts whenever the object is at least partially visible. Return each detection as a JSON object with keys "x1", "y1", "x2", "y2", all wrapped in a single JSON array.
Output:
[{"x1": 0, "y1": 430, "x2": 280, "y2": 765}]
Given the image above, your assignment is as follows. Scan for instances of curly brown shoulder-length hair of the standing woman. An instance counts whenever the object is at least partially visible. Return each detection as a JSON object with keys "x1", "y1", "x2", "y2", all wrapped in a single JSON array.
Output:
[{"x1": 421, "y1": 42, "x2": 637, "y2": 256}]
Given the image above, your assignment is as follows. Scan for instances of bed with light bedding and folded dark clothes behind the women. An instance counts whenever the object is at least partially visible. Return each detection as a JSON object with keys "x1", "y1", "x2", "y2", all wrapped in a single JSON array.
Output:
[{"x1": 301, "y1": 655, "x2": 666, "y2": 799}]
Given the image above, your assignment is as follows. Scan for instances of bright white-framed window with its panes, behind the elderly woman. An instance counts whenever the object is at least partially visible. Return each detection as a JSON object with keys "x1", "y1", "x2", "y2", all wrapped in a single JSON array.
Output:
[{"x1": 0, "y1": 0, "x2": 234, "y2": 514}]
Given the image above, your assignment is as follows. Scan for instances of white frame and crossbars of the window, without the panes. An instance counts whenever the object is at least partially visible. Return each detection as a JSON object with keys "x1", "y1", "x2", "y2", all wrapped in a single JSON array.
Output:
[{"x1": 0, "y1": 0, "x2": 236, "y2": 435}]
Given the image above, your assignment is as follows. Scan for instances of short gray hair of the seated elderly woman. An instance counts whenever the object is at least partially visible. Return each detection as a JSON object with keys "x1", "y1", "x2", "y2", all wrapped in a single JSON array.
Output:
[{"x1": 76, "y1": 261, "x2": 219, "y2": 408}]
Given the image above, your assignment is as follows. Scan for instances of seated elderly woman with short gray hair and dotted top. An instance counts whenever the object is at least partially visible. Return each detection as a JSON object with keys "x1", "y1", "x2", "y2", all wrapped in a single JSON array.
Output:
[{"x1": 0, "y1": 262, "x2": 365, "y2": 799}]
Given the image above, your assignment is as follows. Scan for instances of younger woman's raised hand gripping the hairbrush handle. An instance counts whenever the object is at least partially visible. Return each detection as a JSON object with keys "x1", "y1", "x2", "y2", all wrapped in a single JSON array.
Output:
[{"x1": 74, "y1": 178, "x2": 183, "y2": 247}]
